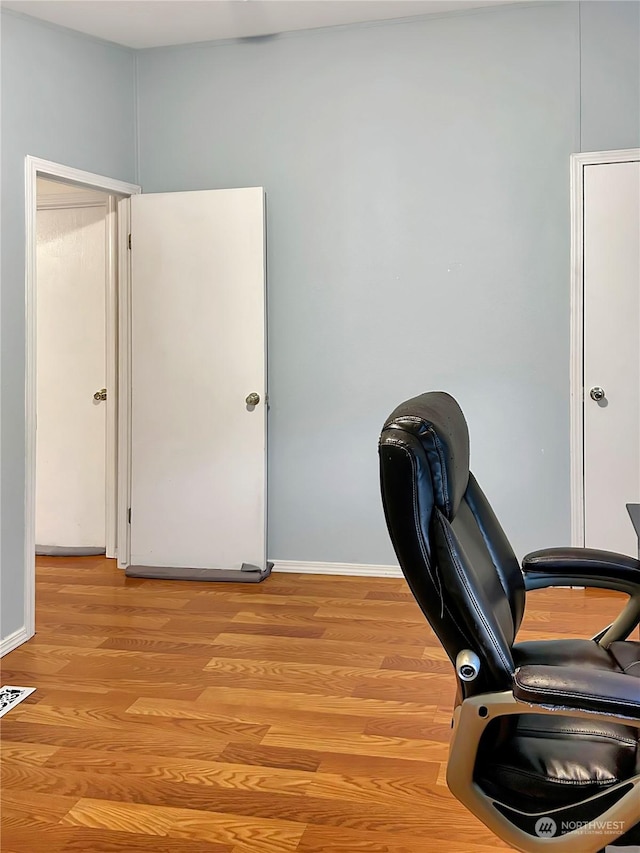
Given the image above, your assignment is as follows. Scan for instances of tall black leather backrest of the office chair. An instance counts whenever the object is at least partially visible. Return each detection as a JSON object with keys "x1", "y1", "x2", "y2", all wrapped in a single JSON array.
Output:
[{"x1": 379, "y1": 391, "x2": 524, "y2": 696}]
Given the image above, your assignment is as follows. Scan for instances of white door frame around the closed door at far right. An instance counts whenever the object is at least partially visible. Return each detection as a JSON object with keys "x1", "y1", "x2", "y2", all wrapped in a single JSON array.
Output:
[{"x1": 569, "y1": 148, "x2": 640, "y2": 548}]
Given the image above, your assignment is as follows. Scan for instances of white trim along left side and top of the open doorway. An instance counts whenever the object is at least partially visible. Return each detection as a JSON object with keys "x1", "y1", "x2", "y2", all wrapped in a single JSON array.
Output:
[{"x1": 24, "y1": 155, "x2": 141, "y2": 639}]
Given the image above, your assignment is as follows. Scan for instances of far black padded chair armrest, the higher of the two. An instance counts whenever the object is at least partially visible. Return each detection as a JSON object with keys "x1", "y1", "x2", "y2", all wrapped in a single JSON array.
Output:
[{"x1": 522, "y1": 548, "x2": 640, "y2": 595}]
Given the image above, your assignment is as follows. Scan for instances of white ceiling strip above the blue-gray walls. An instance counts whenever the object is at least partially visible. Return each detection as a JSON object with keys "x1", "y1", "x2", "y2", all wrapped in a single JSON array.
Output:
[{"x1": 2, "y1": 0, "x2": 518, "y2": 48}]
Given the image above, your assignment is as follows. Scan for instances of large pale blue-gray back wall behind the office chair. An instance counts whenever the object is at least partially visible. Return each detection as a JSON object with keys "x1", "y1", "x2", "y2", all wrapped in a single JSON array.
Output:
[{"x1": 138, "y1": 3, "x2": 580, "y2": 563}]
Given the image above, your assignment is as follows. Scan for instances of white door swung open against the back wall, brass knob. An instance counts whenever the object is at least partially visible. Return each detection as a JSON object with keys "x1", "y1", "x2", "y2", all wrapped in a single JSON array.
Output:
[{"x1": 130, "y1": 188, "x2": 266, "y2": 569}]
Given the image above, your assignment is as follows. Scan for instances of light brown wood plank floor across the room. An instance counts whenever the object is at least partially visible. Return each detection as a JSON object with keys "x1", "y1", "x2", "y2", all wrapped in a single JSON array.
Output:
[{"x1": 2, "y1": 558, "x2": 622, "y2": 853}]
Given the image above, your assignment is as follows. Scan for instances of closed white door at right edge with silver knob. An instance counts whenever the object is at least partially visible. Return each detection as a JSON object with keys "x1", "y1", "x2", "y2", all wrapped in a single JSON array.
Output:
[{"x1": 584, "y1": 161, "x2": 640, "y2": 556}]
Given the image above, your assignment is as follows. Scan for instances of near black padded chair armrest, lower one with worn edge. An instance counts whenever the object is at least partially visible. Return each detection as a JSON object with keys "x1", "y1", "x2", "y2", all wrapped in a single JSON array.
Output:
[{"x1": 513, "y1": 665, "x2": 640, "y2": 720}]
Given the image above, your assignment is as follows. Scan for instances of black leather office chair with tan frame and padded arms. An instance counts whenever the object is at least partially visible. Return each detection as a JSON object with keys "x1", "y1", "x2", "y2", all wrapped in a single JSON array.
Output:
[{"x1": 379, "y1": 392, "x2": 640, "y2": 853}]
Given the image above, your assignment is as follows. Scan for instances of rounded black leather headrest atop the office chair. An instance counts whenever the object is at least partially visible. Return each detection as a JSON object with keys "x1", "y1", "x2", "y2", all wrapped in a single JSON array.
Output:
[{"x1": 381, "y1": 391, "x2": 469, "y2": 520}]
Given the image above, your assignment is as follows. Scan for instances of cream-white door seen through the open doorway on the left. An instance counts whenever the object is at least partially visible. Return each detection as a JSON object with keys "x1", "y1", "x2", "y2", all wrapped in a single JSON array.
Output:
[{"x1": 36, "y1": 206, "x2": 106, "y2": 549}]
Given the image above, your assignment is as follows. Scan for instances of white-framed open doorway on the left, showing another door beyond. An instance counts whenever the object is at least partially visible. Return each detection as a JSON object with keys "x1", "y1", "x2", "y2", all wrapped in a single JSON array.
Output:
[{"x1": 21, "y1": 157, "x2": 140, "y2": 641}]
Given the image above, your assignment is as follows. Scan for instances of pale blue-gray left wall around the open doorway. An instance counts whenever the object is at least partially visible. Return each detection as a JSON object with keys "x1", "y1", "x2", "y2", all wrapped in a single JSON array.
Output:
[{"x1": 1, "y1": 11, "x2": 135, "y2": 637}]
